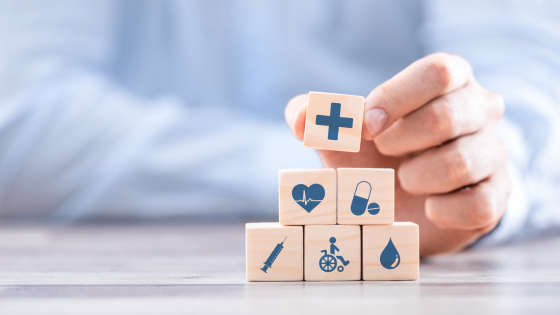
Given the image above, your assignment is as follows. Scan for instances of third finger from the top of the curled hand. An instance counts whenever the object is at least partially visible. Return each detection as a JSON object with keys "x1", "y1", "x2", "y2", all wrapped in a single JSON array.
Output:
[{"x1": 397, "y1": 130, "x2": 507, "y2": 195}]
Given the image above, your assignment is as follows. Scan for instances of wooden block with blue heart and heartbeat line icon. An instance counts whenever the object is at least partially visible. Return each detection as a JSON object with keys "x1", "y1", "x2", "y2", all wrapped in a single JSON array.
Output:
[{"x1": 278, "y1": 168, "x2": 336, "y2": 225}]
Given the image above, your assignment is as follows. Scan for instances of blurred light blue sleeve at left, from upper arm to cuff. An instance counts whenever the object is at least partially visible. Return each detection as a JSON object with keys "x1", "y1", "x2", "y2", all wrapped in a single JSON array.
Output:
[{"x1": 0, "y1": 0, "x2": 320, "y2": 219}]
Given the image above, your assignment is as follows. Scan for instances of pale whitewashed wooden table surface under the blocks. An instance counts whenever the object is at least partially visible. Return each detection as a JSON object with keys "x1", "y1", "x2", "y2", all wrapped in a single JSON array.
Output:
[{"x1": 0, "y1": 222, "x2": 560, "y2": 315}]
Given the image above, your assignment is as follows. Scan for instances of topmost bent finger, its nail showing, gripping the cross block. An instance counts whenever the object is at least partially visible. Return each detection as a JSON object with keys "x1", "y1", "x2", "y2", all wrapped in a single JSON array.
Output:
[{"x1": 364, "y1": 53, "x2": 472, "y2": 139}]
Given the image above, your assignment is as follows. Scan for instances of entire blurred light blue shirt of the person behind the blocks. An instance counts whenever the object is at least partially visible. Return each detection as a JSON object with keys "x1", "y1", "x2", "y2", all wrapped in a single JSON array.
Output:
[{"x1": 0, "y1": 0, "x2": 560, "y2": 244}]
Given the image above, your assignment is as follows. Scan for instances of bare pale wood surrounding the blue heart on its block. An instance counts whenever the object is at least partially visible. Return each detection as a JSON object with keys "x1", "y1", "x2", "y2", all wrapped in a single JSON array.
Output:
[{"x1": 278, "y1": 168, "x2": 336, "y2": 225}]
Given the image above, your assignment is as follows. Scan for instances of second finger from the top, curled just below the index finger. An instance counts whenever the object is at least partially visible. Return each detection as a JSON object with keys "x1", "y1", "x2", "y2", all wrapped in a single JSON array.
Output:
[{"x1": 375, "y1": 81, "x2": 504, "y2": 156}]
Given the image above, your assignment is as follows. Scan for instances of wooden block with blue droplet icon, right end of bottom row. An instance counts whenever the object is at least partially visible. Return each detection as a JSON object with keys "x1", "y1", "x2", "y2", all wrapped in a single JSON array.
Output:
[{"x1": 362, "y1": 222, "x2": 420, "y2": 280}]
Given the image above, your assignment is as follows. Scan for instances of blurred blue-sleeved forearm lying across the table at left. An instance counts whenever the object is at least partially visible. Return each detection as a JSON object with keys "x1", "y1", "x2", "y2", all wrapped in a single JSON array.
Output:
[{"x1": 0, "y1": 74, "x2": 318, "y2": 217}]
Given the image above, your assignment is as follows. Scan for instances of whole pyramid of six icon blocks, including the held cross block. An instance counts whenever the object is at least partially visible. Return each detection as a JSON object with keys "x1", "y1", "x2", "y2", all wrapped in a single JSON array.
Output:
[{"x1": 246, "y1": 92, "x2": 419, "y2": 281}]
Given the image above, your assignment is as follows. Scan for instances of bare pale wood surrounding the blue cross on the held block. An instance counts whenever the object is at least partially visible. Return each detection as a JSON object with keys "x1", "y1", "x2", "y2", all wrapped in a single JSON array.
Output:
[{"x1": 303, "y1": 92, "x2": 364, "y2": 152}]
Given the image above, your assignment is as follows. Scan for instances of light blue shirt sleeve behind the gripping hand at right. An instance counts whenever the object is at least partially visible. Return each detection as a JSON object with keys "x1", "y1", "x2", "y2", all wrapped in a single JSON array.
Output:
[{"x1": 421, "y1": 0, "x2": 560, "y2": 245}]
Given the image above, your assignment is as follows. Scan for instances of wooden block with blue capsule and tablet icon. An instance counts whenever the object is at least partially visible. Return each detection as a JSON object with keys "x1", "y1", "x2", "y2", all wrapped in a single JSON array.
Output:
[{"x1": 337, "y1": 168, "x2": 395, "y2": 225}]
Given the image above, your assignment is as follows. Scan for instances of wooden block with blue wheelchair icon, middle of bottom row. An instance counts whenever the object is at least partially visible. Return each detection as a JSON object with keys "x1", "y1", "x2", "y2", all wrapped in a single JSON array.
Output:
[{"x1": 304, "y1": 225, "x2": 362, "y2": 281}]
